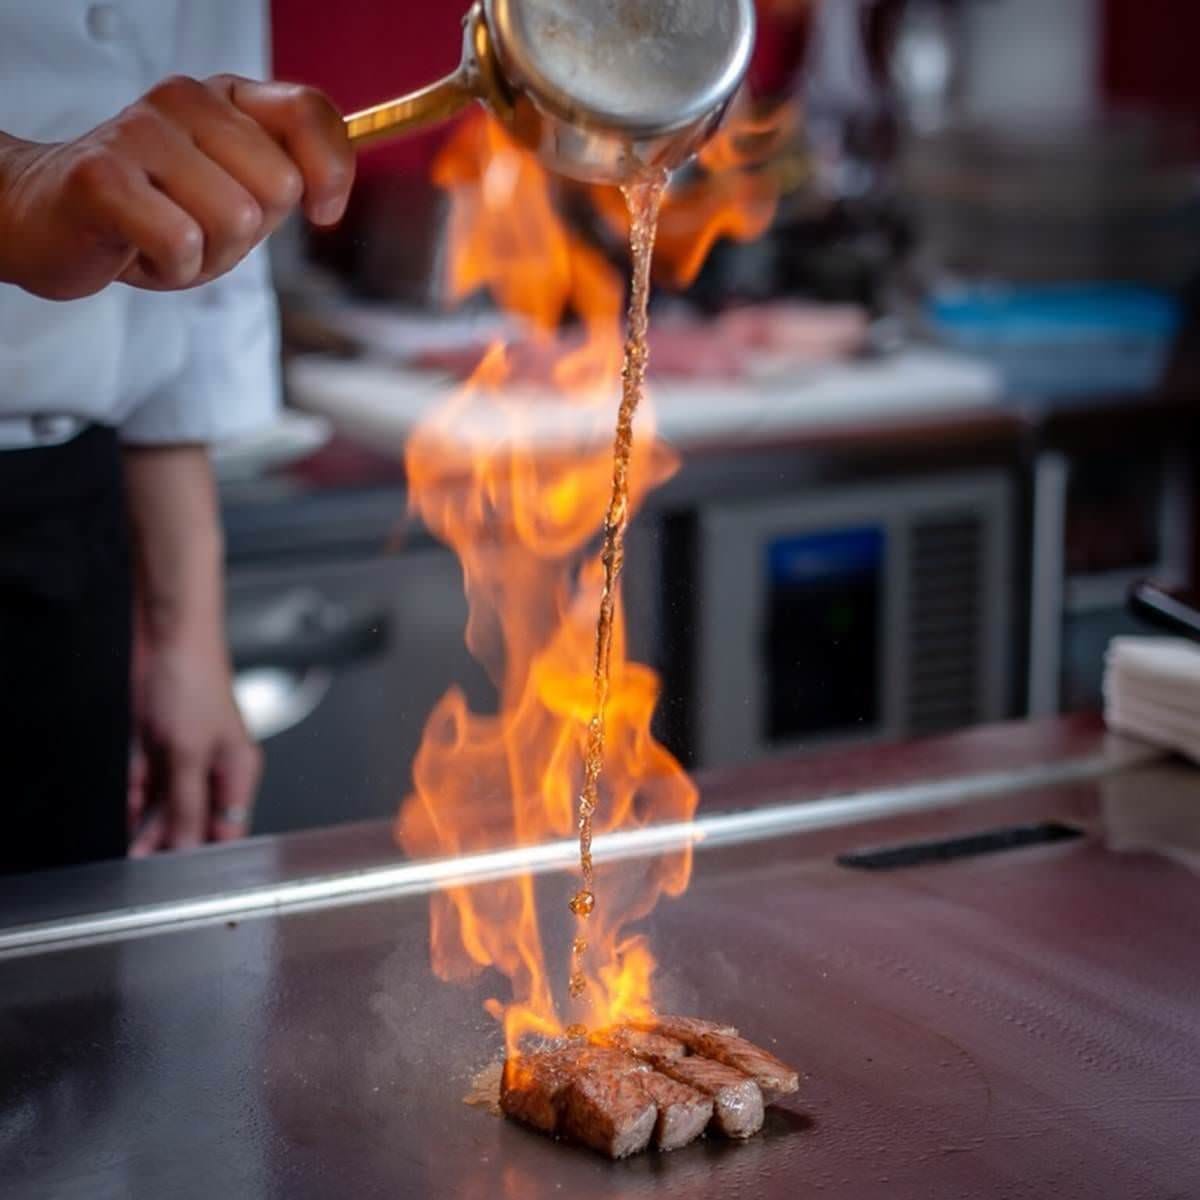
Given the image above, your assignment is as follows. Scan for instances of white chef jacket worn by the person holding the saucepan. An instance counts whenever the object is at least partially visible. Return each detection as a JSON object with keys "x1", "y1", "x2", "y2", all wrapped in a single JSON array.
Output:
[{"x1": 0, "y1": 0, "x2": 280, "y2": 449}]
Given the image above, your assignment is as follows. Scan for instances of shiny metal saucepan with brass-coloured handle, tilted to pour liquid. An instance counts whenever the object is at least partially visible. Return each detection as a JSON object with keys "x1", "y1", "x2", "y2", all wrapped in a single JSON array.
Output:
[{"x1": 346, "y1": 0, "x2": 755, "y2": 184}]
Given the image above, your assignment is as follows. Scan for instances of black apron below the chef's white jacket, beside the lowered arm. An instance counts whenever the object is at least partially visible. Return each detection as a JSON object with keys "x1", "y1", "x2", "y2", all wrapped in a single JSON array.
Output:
[{"x1": 0, "y1": 426, "x2": 132, "y2": 872}]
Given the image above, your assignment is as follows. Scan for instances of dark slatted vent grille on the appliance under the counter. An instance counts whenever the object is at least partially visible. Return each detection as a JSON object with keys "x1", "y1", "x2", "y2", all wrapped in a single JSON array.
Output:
[{"x1": 907, "y1": 512, "x2": 986, "y2": 733}]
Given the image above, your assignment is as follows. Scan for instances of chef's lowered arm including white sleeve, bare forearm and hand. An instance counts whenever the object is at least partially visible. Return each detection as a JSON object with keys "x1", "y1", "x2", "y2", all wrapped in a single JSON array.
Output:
[{"x1": 121, "y1": 231, "x2": 280, "y2": 856}]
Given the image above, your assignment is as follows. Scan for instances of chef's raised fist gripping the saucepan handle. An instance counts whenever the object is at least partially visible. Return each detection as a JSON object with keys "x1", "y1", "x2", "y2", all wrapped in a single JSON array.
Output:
[{"x1": 0, "y1": 76, "x2": 354, "y2": 300}]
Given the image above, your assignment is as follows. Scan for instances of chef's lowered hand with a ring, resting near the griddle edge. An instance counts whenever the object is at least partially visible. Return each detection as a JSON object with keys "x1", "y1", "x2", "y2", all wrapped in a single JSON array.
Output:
[{"x1": 130, "y1": 640, "x2": 263, "y2": 858}]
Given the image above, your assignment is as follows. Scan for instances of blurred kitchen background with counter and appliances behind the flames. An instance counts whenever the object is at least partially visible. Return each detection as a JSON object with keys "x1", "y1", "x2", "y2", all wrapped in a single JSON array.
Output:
[{"x1": 220, "y1": 0, "x2": 1200, "y2": 833}]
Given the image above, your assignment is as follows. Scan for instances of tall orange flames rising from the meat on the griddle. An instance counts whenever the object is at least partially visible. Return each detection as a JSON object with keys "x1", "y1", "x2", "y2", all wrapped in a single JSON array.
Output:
[{"x1": 396, "y1": 108, "x2": 792, "y2": 1050}]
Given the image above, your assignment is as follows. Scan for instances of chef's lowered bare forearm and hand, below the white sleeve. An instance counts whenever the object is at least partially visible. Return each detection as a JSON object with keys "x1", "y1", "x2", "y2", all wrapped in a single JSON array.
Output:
[{"x1": 125, "y1": 445, "x2": 262, "y2": 856}]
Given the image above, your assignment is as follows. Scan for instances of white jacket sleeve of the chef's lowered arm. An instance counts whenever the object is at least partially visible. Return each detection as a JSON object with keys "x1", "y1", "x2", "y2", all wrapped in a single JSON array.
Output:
[{"x1": 121, "y1": 0, "x2": 281, "y2": 445}]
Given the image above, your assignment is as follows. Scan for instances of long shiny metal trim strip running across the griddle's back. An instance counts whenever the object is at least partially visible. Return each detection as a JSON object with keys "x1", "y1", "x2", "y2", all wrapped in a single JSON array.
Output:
[{"x1": 0, "y1": 746, "x2": 1154, "y2": 959}]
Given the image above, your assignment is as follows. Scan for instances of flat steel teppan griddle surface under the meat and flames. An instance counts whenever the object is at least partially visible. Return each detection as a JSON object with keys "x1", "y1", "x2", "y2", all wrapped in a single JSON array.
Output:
[{"x1": 0, "y1": 726, "x2": 1200, "y2": 1200}]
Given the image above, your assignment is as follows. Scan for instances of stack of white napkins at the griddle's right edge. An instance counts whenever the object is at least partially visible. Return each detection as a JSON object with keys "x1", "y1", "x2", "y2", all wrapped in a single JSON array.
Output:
[{"x1": 1104, "y1": 637, "x2": 1200, "y2": 762}]
